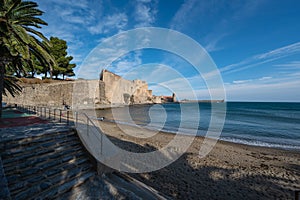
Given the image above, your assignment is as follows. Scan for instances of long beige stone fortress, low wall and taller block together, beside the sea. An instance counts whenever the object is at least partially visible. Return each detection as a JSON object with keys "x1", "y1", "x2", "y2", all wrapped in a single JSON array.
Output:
[{"x1": 3, "y1": 70, "x2": 176, "y2": 107}]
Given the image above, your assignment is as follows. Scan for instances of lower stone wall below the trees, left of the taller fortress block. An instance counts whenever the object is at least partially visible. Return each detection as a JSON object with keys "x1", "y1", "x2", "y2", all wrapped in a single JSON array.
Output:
[{"x1": 3, "y1": 80, "x2": 105, "y2": 107}]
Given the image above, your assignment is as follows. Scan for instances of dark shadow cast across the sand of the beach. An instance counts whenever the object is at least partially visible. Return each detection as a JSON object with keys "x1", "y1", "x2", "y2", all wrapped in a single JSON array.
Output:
[{"x1": 102, "y1": 133, "x2": 299, "y2": 199}]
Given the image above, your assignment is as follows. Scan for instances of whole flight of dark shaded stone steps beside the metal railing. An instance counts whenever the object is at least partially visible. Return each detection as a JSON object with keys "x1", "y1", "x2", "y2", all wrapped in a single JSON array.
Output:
[{"x1": 0, "y1": 126, "x2": 96, "y2": 199}]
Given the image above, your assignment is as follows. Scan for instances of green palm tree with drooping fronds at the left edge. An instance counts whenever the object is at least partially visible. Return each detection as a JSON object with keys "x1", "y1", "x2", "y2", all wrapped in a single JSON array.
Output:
[{"x1": 0, "y1": 0, "x2": 55, "y2": 117}]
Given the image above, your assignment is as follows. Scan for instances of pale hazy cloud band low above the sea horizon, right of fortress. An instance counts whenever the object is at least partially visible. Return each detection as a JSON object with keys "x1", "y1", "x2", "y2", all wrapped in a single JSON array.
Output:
[{"x1": 164, "y1": 76, "x2": 300, "y2": 101}]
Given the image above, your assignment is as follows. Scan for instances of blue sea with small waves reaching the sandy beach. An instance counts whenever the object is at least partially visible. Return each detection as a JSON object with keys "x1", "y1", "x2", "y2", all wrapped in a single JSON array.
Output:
[{"x1": 97, "y1": 102, "x2": 300, "y2": 150}]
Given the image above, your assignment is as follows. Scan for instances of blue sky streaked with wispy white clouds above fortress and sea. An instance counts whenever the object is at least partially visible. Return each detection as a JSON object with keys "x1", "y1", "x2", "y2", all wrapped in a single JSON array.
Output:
[{"x1": 36, "y1": 0, "x2": 300, "y2": 102}]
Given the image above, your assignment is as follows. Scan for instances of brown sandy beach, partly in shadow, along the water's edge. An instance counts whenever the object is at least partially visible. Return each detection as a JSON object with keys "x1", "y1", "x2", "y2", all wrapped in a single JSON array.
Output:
[{"x1": 101, "y1": 122, "x2": 300, "y2": 199}]
